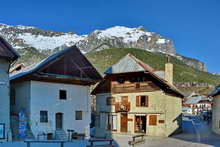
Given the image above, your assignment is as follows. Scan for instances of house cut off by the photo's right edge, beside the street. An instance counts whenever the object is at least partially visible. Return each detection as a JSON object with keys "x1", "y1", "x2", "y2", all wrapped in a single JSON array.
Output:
[{"x1": 209, "y1": 85, "x2": 220, "y2": 135}]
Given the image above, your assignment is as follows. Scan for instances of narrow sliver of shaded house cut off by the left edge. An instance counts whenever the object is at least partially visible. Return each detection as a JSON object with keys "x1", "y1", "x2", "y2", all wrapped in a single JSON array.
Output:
[{"x1": 0, "y1": 37, "x2": 19, "y2": 140}]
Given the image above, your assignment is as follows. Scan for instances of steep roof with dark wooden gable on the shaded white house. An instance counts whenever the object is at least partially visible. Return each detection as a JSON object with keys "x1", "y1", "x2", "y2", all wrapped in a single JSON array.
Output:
[{"x1": 10, "y1": 46, "x2": 102, "y2": 84}]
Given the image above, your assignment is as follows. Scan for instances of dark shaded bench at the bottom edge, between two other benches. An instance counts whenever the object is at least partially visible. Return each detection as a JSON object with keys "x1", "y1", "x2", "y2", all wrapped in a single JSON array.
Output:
[{"x1": 87, "y1": 139, "x2": 114, "y2": 147}]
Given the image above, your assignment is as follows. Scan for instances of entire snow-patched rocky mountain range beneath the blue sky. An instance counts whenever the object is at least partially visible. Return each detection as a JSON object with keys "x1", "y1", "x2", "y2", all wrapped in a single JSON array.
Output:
[{"x1": 0, "y1": 24, "x2": 206, "y2": 71}]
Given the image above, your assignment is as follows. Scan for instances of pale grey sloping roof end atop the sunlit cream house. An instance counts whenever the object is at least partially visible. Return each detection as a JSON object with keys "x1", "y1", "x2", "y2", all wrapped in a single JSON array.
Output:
[{"x1": 105, "y1": 54, "x2": 154, "y2": 74}]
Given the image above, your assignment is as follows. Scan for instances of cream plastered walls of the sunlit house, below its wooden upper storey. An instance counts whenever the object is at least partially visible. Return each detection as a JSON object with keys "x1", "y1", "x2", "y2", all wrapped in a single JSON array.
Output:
[{"x1": 96, "y1": 91, "x2": 181, "y2": 137}]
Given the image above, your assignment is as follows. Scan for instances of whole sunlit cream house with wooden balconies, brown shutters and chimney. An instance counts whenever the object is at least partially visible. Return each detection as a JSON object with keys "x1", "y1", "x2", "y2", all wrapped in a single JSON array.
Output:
[{"x1": 92, "y1": 54, "x2": 184, "y2": 138}]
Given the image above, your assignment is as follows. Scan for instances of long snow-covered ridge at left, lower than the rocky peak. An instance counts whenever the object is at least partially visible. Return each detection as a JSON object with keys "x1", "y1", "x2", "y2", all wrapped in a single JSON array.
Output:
[{"x1": 0, "y1": 24, "x2": 85, "y2": 50}]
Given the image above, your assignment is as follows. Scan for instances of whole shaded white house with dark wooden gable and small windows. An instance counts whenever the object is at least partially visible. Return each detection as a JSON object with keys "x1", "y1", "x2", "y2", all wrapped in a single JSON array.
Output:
[{"x1": 10, "y1": 46, "x2": 102, "y2": 140}]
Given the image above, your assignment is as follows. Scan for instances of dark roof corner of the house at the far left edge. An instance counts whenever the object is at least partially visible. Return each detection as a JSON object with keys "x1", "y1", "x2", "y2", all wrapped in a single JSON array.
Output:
[{"x1": 0, "y1": 36, "x2": 19, "y2": 62}]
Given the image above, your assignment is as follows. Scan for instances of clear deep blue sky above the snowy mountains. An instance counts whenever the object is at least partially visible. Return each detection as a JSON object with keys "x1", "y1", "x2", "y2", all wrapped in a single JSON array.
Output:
[{"x1": 0, "y1": 0, "x2": 220, "y2": 73}]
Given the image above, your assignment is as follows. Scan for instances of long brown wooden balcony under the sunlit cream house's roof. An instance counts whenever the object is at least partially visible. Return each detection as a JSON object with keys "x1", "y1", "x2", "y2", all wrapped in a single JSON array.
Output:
[{"x1": 111, "y1": 82, "x2": 158, "y2": 93}]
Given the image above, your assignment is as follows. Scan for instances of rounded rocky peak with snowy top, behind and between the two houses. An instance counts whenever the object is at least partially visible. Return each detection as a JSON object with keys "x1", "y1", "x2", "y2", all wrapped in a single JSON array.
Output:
[{"x1": 78, "y1": 26, "x2": 176, "y2": 55}]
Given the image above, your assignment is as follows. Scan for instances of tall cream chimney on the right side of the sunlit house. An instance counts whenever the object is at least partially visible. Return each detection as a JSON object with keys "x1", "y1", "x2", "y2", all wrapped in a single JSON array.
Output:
[{"x1": 165, "y1": 55, "x2": 173, "y2": 85}]
